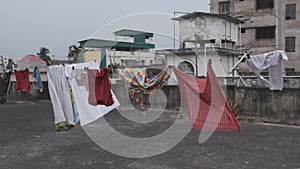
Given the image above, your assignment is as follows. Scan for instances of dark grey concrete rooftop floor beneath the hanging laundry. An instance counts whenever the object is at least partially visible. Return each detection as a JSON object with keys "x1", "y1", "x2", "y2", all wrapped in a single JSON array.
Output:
[{"x1": 0, "y1": 102, "x2": 300, "y2": 169}]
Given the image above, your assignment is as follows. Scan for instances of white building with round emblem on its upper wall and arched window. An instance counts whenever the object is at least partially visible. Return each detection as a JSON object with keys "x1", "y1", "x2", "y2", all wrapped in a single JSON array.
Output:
[{"x1": 156, "y1": 12, "x2": 241, "y2": 80}]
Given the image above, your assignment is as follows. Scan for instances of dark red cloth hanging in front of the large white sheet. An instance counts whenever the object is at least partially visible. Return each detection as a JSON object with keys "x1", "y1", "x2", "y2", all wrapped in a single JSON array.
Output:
[{"x1": 88, "y1": 68, "x2": 114, "y2": 106}]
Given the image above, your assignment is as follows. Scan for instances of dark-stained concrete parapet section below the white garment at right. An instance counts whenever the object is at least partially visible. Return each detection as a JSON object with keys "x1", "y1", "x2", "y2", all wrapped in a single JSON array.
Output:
[{"x1": 235, "y1": 87, "x2": 300, "y2": 120}]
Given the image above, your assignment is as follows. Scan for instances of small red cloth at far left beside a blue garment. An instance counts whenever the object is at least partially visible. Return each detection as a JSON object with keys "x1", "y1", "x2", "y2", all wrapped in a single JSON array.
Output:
[{"x1": 15, "y1": 70, "x2": 31, "y2": 91}]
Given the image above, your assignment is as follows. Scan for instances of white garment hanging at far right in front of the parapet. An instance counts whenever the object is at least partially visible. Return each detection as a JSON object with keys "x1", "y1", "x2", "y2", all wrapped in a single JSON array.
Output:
[{"x1": 247, "y1": 50, "x2": 288, "y2": 90}]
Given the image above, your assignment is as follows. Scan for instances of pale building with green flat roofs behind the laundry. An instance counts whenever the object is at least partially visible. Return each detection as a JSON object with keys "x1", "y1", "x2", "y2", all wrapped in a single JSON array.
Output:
[{"x1": 78, "y1": 29, "x2": 155, "y2": 67}]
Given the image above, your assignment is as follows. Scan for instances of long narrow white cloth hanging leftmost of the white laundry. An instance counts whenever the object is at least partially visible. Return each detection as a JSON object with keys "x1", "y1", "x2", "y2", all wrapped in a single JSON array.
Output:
[{"x1": 47, "y1": 66, "x2": 75, "y2": 125}]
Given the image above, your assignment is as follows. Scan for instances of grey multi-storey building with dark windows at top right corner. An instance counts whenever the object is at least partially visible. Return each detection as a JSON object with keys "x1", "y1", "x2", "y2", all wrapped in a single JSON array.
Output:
[{"x1": 210, "y1": 0, "x2": 300, "y2": 75}]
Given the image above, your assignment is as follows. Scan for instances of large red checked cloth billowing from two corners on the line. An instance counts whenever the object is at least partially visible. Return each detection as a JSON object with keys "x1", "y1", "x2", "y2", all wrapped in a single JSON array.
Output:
[{"x1": 173, "y1": 62, "x2": 241, "y2": 131}]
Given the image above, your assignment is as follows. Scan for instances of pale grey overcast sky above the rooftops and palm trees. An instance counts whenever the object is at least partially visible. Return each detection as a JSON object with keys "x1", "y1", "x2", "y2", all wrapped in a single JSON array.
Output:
[{"x1": 0, "y1": 0, "x2": 209, "y2": 59}]
